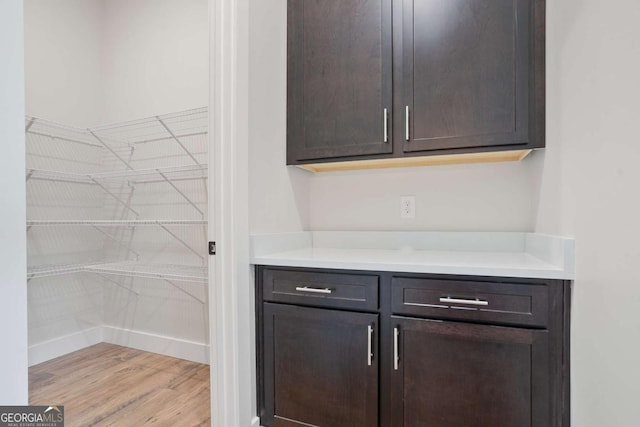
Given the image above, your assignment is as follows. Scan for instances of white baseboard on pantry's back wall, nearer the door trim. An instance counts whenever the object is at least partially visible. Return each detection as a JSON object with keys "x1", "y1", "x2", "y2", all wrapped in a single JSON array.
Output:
[{"x1": 103, "y1": 325, "x2": 209, "y2": 364}]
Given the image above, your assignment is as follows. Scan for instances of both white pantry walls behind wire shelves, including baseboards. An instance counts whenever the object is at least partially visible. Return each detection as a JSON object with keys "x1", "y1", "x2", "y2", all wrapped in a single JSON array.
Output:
[{"x1": 25, "y1": 0, "x2": 208, "y2": 364}]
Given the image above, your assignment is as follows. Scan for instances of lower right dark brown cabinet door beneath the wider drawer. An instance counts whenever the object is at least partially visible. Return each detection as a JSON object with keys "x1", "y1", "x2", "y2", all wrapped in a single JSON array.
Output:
[{"x1": 391, "y1": 316, "x2": 551, "y2": 427}]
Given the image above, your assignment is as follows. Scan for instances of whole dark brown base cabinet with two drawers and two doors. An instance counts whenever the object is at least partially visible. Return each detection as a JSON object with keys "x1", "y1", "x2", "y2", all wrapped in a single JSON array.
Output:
[{"x1": 256, "y1": 266, "x2": 570, "y2": 427}]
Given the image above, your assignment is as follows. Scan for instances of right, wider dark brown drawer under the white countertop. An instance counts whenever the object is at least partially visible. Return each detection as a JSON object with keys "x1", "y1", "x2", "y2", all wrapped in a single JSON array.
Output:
[{"x1": 391, "y1": 277, "x2": 548, "y2": 327}]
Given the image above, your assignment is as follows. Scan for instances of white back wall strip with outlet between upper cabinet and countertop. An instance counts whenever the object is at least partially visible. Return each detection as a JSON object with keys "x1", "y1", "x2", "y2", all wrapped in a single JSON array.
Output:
[{"x1": 309, "y1": 160, "x2": 537, "y2": 231}]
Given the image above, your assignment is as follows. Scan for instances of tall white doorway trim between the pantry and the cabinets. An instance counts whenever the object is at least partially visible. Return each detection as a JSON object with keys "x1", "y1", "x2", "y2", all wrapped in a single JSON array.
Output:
[{"x1": 209, "y1": 0, "x2": 251, "y2": 427}]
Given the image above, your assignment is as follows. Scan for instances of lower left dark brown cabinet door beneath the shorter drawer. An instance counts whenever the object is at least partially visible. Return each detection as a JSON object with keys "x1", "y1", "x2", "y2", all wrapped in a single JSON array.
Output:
[{"x1": 261, "y1": 303, "x2": 378, "y2": 427}]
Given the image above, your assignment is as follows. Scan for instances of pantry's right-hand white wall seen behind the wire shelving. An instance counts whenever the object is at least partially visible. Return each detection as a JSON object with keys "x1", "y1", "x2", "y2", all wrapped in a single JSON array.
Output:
[{"x1": 101, "y1": 0, "x2": 209, "y2": 361}]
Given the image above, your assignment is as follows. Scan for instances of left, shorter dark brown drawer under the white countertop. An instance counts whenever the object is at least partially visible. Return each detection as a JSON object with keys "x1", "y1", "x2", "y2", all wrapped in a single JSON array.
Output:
[{"x1": 263, "y1": 269, "x2": 378, "y2": 310}]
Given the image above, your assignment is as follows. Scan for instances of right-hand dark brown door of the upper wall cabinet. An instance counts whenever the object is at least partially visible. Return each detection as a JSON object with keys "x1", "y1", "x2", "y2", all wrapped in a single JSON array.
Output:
[{"x1": 402, "y1": 0, "x2": 544, "y2": 152}]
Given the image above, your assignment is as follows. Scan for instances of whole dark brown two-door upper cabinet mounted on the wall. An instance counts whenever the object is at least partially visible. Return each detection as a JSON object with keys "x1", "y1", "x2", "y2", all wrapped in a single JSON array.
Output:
[{"x1": 287, "y1": 0, "x2": 545, "y2": 170}]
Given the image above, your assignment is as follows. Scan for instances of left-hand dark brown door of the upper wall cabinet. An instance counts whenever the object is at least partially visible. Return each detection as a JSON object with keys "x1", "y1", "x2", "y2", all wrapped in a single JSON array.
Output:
[{"x1": 287, "y1": 0, "x2": 392, "y2": 164}]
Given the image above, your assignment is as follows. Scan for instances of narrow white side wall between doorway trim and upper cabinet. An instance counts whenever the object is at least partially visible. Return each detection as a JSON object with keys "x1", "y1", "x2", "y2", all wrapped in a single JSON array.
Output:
[{"x1": 249, "y1": 0, "x2": 310, "y2": 233}]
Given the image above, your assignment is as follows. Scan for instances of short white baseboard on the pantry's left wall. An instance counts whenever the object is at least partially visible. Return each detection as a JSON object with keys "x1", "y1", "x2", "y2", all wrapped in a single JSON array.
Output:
[{"x1": 29, "y1": 326, "x2": 103, "y2": 366}]
